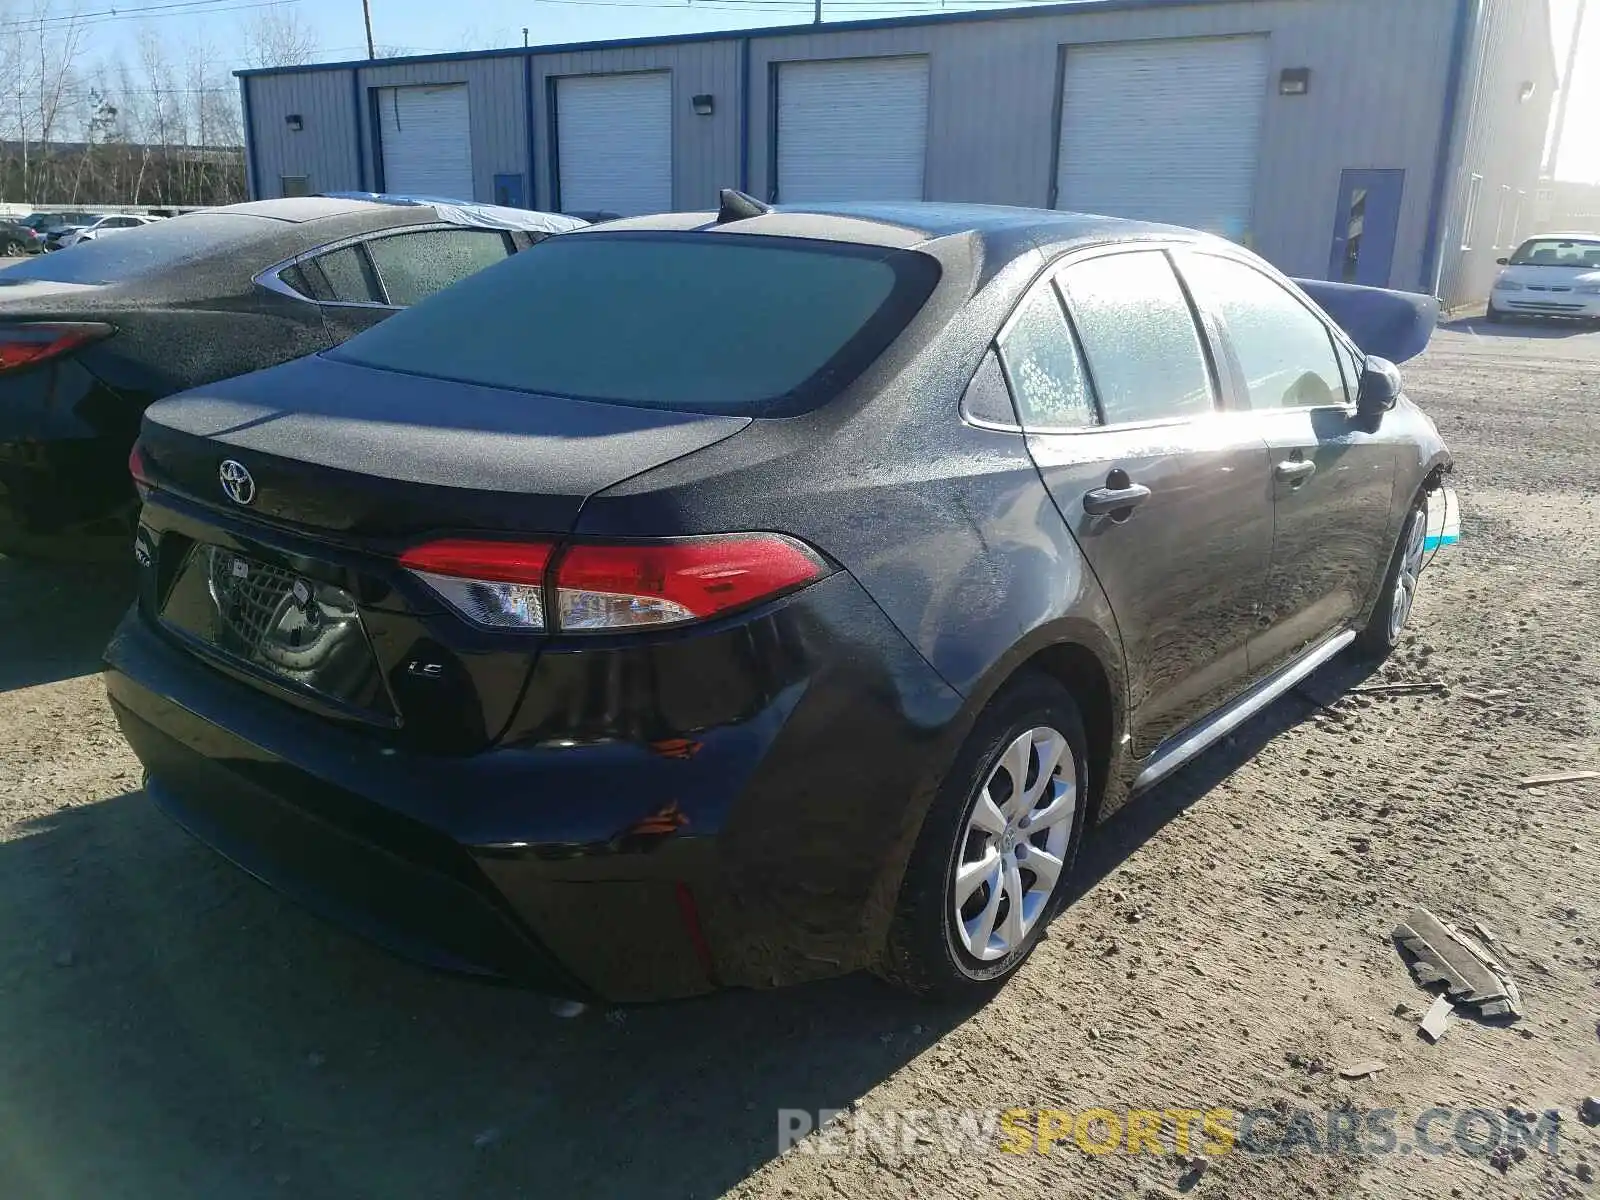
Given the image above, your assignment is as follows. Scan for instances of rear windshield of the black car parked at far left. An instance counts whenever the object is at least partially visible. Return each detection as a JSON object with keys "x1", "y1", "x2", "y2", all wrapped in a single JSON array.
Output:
[{"x1": 5, "y1": 213, "x2": 272, "y2": 283}]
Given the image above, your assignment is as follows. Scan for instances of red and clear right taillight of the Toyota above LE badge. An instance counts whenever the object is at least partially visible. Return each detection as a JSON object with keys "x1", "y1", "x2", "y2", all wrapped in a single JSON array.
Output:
[{"x1": 400, "y1": 533, "x2": 827, "y2": 634}]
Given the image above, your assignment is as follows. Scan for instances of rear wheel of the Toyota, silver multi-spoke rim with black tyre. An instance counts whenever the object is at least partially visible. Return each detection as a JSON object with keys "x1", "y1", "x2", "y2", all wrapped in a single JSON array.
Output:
[{"x1": 878, "y1": 674, "x2": 1088, "y2": 997}]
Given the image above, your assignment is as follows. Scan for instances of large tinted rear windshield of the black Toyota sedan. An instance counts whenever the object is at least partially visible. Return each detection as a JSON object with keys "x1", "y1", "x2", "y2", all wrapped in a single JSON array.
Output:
[{"x1": 331, "y1": 234, "x2": 939, "y2": 416}]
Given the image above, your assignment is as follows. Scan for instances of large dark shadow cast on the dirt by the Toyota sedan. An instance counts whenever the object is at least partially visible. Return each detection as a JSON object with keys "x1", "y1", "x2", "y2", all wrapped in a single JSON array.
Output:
[{"x1": 0, "y1": 662, "x2": 1366, "y2": 1200}]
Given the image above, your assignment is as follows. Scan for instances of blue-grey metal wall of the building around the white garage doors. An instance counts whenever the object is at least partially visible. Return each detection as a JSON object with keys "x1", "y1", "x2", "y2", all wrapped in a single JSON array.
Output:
[{"x1": 251, "y1": 0, "x2": 1484, "y2": 283}]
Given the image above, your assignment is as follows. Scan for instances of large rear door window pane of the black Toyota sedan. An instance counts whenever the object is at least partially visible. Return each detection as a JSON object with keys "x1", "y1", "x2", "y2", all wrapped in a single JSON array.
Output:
[{"x1": 1058, "y1": 250, "x2": 1216, "y2": 424}]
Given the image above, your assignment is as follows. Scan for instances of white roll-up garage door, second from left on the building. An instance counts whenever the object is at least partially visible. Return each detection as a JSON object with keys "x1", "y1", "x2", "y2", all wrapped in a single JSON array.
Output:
[{"x1": 555, "y1": 70, "x2": 672, "y2": 216}]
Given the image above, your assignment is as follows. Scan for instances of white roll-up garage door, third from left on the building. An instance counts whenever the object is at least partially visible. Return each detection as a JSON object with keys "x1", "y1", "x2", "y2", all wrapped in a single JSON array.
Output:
[{"x1": 778, "y1": 58, "x2": 928, "y2": 203}]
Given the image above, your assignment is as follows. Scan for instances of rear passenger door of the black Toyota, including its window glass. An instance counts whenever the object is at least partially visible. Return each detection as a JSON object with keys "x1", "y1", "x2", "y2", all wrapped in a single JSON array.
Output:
[{"x1": 1000, "y1": 248, "x2": 1272, "y2": 757}]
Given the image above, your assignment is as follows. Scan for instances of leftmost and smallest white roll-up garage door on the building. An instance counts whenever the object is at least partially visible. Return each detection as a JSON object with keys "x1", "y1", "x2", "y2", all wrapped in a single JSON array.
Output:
[{"x1": 378, "y1": 83, "x2": 474, "y2": 200}]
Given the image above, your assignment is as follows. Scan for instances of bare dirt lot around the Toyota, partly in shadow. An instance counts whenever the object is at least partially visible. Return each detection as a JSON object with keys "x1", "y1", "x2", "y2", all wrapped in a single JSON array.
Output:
[{"x1": 0, "y1": 315, "x2": 1600, "y2": 1200}]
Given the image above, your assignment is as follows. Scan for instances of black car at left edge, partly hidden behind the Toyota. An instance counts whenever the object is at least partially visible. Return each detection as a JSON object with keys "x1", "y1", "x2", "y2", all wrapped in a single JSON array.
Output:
[{"x1": 0, "y1": 197, "x2": 582, "y2": 555}]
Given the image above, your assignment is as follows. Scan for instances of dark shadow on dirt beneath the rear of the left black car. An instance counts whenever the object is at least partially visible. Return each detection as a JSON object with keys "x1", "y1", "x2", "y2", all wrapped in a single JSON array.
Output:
[{"x1": 0, "y1": 554, "x2": 136, "y2": 691}]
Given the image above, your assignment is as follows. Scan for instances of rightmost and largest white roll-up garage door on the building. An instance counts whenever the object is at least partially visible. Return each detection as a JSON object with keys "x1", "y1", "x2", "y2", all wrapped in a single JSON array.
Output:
[{"x1": 1056, "y1": 37, "x2": 1267, "y2": 240}]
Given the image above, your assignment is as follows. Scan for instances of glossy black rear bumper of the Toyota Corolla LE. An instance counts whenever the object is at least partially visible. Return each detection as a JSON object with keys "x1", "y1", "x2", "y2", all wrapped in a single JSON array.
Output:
[{"x1": 106, "y1": 576, "x2": 960, "y2": 1000}]
